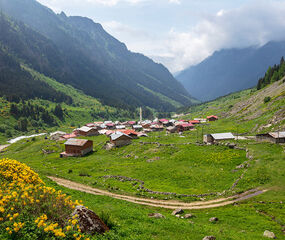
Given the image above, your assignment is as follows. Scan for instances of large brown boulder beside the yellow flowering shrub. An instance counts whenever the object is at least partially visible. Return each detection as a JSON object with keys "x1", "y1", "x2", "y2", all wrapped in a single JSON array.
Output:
[{"x1": 72, "y1": 205, "x2": 109, "y2": 234}]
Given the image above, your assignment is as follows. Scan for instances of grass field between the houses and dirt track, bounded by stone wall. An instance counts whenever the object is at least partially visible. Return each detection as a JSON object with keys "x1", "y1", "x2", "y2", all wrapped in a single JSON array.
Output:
[{"x1": 0, "y1": 133, "x2": 246, "y2": 199}]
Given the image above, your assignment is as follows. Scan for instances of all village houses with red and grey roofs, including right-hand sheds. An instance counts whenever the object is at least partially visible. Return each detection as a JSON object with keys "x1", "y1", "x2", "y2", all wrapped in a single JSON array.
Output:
[{"x1": 47, "y1": 115, "x2": 285, "y2": 158}]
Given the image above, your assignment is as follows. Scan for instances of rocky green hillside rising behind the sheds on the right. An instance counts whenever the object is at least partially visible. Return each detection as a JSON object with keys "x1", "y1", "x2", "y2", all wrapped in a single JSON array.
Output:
[{"x1": 183, "y1": 78, "x2": 285, "y2": 134}]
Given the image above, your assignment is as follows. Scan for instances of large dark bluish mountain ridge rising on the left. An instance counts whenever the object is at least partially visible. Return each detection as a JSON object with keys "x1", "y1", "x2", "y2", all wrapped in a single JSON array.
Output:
[{"x1": 0, "y1": 0, "x2": 192, "y2": 111}]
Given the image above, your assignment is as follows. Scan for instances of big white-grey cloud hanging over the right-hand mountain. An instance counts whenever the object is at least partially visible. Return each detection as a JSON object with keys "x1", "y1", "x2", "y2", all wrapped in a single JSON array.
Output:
[{"x1": 153, "y1": 0, "x2": 285, "y2": 72}]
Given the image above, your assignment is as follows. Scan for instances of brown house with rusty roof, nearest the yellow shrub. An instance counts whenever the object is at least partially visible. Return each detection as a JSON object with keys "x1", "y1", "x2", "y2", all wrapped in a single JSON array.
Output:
[{"x1": 60, "y1": 138, "x2": 93, "y2": 157}]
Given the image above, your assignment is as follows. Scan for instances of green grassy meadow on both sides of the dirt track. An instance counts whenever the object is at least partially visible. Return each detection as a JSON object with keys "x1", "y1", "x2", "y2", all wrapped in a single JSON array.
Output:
[{"x1": 0, "y1": 124, "x2": 285, "y2": 240}]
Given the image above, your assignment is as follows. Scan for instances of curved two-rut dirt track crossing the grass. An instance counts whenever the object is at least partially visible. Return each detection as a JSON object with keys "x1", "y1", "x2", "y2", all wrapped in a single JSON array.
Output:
[{"x1": 48, "y1": 177, "x2": 268, "y2": 210}]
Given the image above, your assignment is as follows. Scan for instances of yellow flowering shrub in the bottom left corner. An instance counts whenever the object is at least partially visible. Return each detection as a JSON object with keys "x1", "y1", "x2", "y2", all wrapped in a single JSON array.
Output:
[{"x1": 0, "y1": 159, "x2": 88, "y2": 239}]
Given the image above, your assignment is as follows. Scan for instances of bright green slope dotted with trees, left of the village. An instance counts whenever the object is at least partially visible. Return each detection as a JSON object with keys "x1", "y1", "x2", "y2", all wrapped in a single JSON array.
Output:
[{"x1": 0, "y1": 65, "x2": 138, "y2": 145}]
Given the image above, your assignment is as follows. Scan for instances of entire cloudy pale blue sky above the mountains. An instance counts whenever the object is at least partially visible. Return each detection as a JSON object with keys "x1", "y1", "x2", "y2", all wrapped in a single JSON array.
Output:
[{"x1": 38, "y1": 0, "x2": 285, "y2": 73}]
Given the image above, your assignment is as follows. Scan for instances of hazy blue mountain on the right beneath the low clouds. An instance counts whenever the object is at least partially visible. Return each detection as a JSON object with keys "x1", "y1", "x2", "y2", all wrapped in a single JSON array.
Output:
[{"x1": 176, "y1": 41, "x2": 285, "y2": 101}]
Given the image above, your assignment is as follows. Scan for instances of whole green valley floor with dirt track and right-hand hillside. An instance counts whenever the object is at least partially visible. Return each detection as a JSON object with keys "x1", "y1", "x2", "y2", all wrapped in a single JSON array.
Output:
[{"x1": 0, "y1": 80, "x2": 285, "y2": 239}]
